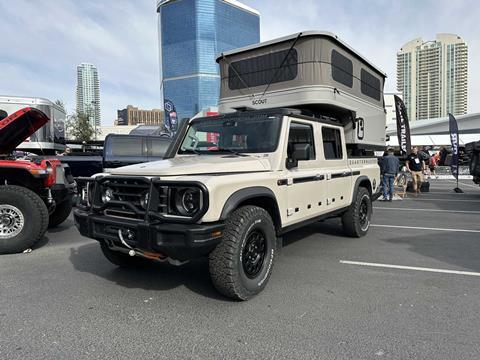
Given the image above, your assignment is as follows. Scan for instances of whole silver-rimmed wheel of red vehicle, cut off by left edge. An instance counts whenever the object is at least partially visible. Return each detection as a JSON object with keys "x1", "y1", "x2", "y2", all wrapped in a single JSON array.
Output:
[{"x1": 0, "y1": 185, "x2": 48, "y2": 254}]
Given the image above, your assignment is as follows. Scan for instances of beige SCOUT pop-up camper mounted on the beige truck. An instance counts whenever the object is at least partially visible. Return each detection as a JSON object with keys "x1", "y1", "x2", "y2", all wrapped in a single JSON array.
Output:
[{"x1": 217, "y1": 31, "x2": 386, "y2": 149}]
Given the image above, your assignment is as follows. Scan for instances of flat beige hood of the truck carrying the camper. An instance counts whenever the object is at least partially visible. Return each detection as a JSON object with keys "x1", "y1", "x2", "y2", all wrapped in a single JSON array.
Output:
[{"x1": 108, "y1": 155, "x2": 271, "y2": 176}]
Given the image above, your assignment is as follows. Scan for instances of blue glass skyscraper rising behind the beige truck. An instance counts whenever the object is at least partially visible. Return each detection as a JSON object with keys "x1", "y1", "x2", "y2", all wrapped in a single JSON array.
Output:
[{"x1": 157, "y1": 0, "x2": 260, "y2": 119}]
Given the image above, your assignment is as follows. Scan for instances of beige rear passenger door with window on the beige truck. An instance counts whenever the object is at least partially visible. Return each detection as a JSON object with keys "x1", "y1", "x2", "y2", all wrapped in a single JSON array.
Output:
[{"x1": 321, "y1": 125, "x2": 352, "y2": 211}]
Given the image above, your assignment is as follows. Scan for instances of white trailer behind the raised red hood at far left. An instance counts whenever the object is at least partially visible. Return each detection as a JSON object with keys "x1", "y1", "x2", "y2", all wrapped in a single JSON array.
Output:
[{"x1": 0, "y1": 95, "x2": 66, "y2": 155}]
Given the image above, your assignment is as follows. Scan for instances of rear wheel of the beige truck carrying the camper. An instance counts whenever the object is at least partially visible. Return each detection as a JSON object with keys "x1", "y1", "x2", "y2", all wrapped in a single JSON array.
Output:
[{"x1": 342, "y1": 187, "x2": 373, "y2": 237}]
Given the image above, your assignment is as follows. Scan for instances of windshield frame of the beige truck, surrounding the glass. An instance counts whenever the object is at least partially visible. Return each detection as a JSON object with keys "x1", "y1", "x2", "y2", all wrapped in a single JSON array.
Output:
[{"x1": 177, "y1": 112, "x2": 284, "y2": 156}]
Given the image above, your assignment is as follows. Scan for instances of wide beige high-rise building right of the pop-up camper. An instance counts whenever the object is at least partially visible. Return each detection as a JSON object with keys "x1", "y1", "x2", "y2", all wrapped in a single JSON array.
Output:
[{"x1": 397, "y1": 34, "x2": 468, "y2": 120}]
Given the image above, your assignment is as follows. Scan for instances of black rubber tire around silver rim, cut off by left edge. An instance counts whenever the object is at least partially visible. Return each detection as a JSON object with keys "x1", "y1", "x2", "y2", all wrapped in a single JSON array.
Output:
[{"x1": 0, "y1": 185, "x2": 48, "y2": 254}]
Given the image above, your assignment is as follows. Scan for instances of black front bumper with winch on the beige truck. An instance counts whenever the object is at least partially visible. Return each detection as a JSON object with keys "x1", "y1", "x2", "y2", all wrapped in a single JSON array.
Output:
[{"x1": 74, "y1": 209, "x2": 225, "y2": 261}]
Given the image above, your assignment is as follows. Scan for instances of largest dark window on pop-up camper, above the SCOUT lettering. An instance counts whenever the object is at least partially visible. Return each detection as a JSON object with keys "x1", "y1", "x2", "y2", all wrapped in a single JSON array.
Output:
[{"x1": 228, "y1": 49, "x2": 298, "y2": 90}]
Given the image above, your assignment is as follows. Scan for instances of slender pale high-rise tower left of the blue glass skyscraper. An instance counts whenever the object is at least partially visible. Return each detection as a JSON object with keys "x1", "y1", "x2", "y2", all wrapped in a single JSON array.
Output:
[{"x1": 77, "y1": 63, "x2": 101, "y2": 127}]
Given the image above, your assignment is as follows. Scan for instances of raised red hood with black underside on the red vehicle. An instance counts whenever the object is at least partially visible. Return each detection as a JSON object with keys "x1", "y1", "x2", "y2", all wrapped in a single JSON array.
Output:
[{"x1": 0, "y1": 107, "x2": 50, "y2": 154}]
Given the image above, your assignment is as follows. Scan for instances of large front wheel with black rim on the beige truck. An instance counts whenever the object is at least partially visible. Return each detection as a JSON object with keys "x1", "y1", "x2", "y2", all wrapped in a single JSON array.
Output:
[{"x1": 209, "y1": 205, "x2": 277, "y2": 300}]
